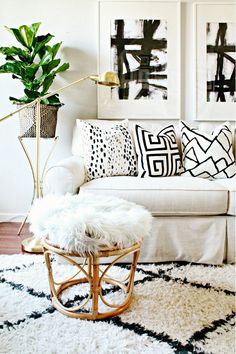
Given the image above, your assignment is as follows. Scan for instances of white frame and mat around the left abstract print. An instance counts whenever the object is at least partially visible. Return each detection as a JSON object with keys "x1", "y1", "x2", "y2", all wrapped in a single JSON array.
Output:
[{"x1": 98, "y1": 0, "x2": 180, "y2": 119}]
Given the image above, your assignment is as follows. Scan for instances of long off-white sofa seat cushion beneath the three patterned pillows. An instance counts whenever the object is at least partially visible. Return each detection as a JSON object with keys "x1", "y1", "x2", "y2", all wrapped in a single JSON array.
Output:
[{"x1": 80, "y1": 176, "x2": 228, "y2": 215}]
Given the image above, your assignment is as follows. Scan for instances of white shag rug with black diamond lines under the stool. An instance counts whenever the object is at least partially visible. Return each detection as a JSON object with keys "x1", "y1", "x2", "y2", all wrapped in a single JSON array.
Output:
[{"x1": 0, "y1": 255, "x2": 235, "y2": 354}]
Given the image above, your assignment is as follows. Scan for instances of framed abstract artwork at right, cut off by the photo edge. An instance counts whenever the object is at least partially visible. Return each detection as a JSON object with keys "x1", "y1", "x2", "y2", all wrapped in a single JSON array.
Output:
[{"x1": 194, "y1": 2, "x2": 236, "y2": 121}]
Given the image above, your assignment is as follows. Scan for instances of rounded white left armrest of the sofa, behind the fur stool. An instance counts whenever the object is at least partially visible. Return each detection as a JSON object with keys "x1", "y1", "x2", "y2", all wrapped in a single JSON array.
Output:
[{"x1": 44, "y1": 156, "x2": 85, "y2": 194}]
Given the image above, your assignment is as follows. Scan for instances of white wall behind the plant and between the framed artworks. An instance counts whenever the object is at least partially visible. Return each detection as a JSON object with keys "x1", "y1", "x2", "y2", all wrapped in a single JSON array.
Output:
[{"x1": 0, "y1": 0, "x2": 233, "y2": 221}]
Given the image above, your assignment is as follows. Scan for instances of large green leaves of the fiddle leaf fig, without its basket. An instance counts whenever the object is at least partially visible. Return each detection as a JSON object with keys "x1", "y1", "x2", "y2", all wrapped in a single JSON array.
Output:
[{"x1": 0, "y1": 22, "x2": 69, "y2": 107}]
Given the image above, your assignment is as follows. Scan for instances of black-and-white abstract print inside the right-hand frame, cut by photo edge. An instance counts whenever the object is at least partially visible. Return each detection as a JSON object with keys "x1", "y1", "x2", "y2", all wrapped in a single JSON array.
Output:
[{"x1": 206, "y1": 22, "x2": 236, "y2": 102}]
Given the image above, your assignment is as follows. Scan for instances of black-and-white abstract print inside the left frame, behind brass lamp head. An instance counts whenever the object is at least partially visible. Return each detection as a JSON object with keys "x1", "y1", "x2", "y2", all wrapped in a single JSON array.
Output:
[{"x1": 111, "y1": 19, "x2": 168, "y2": 101}]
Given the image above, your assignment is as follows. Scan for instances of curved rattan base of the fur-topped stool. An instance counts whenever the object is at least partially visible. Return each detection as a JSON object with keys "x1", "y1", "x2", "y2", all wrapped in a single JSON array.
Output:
[{"x1": 42, "y1": 239, "x2": 140, "y2": 320}]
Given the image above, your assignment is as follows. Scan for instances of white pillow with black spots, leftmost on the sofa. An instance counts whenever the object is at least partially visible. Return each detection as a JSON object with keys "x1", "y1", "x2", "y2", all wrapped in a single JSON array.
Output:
[{"x1": 79, "y1": 120, "x2": 137, "y2": 181}]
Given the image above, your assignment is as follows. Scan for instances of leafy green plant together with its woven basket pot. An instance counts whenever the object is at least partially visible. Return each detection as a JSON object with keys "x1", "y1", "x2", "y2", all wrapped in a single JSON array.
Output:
[{"x1": 0, "y1": 22, "x2": 69, "y2": 138}]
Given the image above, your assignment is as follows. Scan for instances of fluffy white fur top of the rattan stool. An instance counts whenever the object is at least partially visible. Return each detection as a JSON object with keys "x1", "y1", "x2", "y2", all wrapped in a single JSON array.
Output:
[{"x1": 29, "y1": 193, "x2": 152, "y2": 253}]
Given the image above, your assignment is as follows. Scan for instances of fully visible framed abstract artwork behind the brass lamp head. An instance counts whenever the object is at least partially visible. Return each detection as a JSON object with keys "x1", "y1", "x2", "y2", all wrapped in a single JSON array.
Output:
[{"x1": 98, "y1": 1, "x2": 180, "y2": 119}]
